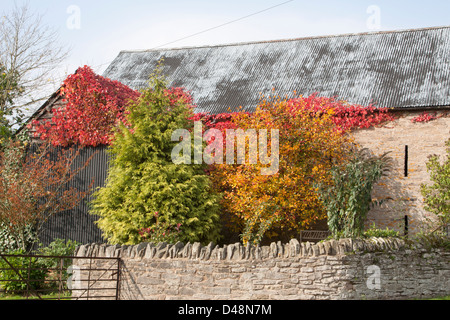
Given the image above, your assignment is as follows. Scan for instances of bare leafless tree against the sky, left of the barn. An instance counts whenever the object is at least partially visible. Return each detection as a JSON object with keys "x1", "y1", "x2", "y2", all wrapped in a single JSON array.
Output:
[{"x1": 0, "y1": 4, "x2": 69, "y2": 130}]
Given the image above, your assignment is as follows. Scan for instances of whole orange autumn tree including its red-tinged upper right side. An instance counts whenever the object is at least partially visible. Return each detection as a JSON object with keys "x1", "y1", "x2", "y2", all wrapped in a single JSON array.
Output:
[{"x1": 211, "y1": 95, "x2": 389, "y2": 244}]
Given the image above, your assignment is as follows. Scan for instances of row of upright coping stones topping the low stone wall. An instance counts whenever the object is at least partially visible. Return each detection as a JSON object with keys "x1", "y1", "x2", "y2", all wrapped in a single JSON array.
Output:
[{"x1": 75, "y1": 237, "x2": 418, "y2": 261}]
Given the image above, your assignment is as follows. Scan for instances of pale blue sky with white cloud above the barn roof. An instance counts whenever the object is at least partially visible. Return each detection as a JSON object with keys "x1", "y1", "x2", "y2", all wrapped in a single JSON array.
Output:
[{"x1": 0, "y1": 0, "x2": 450, "y2": 82}]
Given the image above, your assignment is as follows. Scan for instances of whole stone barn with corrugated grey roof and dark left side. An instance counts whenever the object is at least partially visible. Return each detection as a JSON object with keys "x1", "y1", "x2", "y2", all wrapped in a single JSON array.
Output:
[{"x1": 19, "y1": 27, "x2": 450, "y2": 242}]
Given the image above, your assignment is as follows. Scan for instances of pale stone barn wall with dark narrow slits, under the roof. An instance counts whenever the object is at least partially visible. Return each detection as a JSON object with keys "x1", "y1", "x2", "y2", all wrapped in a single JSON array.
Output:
[{"x1": 353, "y1": 110, "x2": 450, "y2": 234}]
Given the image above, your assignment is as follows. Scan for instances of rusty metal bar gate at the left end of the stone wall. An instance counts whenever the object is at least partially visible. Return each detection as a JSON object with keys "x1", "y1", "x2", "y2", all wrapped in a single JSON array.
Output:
[{"x1": 0, "y1": 254, "x2": 121, "y2": 300}]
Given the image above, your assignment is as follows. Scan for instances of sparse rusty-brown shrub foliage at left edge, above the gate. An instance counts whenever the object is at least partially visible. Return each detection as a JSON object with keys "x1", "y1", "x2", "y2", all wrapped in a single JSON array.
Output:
[{"x1": 0, "y1": 141, "x2": 90, "y2": 251}]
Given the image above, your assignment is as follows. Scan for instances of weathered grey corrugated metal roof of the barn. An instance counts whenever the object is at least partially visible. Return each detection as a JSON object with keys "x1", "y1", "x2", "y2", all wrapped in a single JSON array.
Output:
[{"x1": 104, "y1": 27, "x2": 450, "y2": 113}]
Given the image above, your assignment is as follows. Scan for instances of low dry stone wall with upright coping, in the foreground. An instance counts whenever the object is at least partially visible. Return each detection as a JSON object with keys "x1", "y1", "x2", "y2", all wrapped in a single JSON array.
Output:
[{"x1": 74, "y1": 238, "x2": 450, "y2": 300}]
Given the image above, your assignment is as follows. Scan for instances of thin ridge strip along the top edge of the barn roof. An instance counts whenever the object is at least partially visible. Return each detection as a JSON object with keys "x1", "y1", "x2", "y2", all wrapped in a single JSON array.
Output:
[{"x1": 120, "y1": 26, "x2": 450, "y2": 53}]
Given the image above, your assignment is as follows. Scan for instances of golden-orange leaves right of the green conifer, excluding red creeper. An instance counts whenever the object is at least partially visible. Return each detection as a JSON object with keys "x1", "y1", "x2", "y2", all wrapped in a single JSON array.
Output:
[{"x1": 211, "y1": 96, "x2": 356, "y2": 238}]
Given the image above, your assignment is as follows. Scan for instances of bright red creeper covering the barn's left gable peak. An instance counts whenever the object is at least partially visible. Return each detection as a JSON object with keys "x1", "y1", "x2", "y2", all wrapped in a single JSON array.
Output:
[{"x1": 32, "y1": 66, "x2": 140, "y2": 146}]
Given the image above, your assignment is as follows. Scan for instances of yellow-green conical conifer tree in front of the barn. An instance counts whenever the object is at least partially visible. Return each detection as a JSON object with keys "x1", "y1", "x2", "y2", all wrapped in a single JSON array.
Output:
[{"x1": 91, "y1": 69, "x2": 220, "y2": 244}]
